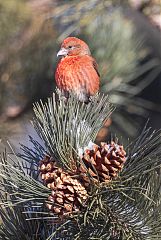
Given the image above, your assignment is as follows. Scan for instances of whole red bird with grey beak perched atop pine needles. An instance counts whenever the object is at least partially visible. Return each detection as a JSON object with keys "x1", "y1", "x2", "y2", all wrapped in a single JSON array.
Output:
[{"x1": 55, "y1": 37, "x2": 100, "y2": 103}]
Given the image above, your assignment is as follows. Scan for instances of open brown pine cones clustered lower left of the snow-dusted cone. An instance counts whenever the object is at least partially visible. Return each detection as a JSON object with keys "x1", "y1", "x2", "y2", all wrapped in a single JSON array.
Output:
[{"x1": 40, "y1": 156, "x2": 87, "y2": 215}]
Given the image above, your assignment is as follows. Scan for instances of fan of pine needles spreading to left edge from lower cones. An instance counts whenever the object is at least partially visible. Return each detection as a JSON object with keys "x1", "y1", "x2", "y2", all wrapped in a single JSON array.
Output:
[{"x1": 0, "y1": 150, "x2": 49, "y2": 206}]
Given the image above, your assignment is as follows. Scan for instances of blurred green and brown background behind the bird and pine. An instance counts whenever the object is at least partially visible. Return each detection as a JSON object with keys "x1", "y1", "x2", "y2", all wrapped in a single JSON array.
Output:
[{"x1": 0, "y1": 0, "x2": 161, "y2": 149}]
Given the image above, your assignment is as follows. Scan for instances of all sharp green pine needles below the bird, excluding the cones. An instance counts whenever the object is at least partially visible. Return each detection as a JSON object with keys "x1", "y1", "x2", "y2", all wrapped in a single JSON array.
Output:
[{"x1": 0, "y1": 92, "x2": 161, "y2": 240}]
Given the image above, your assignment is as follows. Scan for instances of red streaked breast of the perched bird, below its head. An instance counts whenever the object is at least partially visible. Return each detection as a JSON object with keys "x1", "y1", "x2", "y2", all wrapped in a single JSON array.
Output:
[{"x1": 55, "y1": 55, "x2": 99, "y2": 96}]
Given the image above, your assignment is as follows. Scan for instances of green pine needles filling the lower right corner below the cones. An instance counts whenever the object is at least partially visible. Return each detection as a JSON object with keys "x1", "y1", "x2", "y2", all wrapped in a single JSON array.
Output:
[{"x1": 42, "y1": 124, "x2": 161, "y2": 240}]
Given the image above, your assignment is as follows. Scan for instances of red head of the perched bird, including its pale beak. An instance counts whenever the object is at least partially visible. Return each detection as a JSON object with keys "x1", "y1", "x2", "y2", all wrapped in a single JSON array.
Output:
[{"x1": 57, "y1": 37, "x2": 91, "y2": 57}]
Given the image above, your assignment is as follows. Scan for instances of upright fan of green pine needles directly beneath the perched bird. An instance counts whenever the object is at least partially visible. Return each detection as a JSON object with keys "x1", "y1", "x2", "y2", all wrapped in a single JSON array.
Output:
[{"x1": 33, "y1": 90, "x2": 114, "y2": 169}]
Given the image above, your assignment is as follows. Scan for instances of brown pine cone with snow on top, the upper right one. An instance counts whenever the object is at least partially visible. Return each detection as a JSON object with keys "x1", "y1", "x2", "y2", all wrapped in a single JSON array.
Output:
[{"x1": 79, "y1": 141, "x2": 126, "y2": 186}]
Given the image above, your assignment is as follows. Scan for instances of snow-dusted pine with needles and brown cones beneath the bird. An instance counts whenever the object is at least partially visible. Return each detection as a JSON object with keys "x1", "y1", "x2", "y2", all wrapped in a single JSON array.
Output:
[{"x1": 0, "y1": 92, "x2": 161, "y2": 240}]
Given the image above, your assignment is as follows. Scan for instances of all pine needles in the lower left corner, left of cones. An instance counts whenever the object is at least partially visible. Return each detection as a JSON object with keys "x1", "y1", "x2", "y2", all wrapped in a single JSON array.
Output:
[{"x1": 0, "y1": 149, "x2": 56, "y2": 240}]
